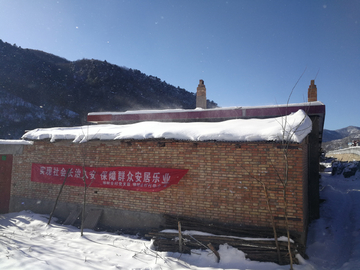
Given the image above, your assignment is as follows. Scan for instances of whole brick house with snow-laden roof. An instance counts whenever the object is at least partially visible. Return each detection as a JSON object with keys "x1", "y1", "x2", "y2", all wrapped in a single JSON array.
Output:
[{"x1": 0, "y1": 81, "x2": 325, "y2": 245}]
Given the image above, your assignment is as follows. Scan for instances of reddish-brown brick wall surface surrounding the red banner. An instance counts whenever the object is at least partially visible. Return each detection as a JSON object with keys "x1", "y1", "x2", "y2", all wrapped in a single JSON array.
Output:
[{"x1": 11, "y1": 140, "x2": 307, "y2": 232}]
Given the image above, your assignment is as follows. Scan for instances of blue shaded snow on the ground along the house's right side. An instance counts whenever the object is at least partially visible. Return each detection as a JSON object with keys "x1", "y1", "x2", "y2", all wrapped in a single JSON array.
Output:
[{"x1": 307, "y1": 163, "x2": 360, "y2": 270}]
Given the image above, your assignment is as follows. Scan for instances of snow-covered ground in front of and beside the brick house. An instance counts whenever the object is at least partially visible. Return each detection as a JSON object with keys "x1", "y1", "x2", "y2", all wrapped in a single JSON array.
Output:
[{"x1": 0, "y1": 166, "x2": 360, "y2": 270}]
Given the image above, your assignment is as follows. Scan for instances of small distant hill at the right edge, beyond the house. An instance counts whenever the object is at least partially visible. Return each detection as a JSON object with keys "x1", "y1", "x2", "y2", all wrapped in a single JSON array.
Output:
[{"x1": 321, "y1": 126, "x2": 360, "y2": 151}]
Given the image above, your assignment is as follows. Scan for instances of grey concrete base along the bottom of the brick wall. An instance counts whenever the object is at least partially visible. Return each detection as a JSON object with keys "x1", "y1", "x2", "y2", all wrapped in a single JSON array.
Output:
[{"x1": 10, "y1": 196, "x2": 165, "y2": 232}]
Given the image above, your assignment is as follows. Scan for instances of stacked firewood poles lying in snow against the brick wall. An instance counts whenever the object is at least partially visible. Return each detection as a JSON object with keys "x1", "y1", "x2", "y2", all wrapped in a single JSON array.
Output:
[{"x1": 147, "y1": 216, "x2": 304, "y2": 265}]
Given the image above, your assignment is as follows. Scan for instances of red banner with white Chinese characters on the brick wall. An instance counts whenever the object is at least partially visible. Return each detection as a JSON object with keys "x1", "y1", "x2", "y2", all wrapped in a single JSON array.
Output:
[{"x1": 31, "y1": 163, "x2": 188, "y2": 192}]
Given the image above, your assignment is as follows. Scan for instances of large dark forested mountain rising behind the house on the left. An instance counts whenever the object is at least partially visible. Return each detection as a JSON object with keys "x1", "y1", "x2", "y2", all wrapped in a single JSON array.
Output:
[{"x1": 0, "y1": 39, "x2": 217, "y2": 139}]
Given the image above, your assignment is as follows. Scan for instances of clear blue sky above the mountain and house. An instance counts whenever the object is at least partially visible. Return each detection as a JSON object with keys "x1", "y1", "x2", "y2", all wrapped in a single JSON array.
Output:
[{"x1": 0, "y1": 0, "x2": 360, "y2": 130}]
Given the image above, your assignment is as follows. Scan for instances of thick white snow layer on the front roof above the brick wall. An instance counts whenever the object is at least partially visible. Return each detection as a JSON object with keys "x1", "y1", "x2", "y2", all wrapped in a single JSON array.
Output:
[{"x1": 22, "y1": 110, "x2": 312, "y2": 143}]
